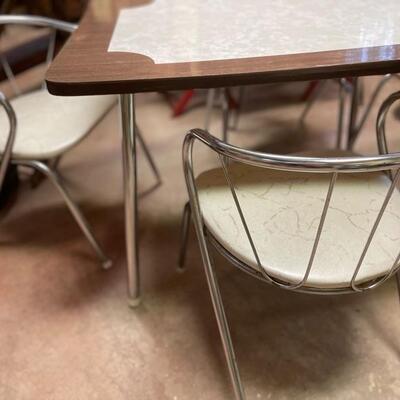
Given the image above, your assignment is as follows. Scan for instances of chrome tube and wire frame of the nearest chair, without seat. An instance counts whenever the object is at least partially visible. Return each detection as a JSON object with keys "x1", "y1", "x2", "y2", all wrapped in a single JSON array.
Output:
[{"x1": 183, "y1": 92, "x2": 400, "y2": 400}]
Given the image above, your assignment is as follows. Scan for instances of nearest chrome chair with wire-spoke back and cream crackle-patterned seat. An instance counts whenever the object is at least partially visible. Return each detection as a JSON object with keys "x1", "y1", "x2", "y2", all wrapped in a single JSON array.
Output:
[{"x1": 183, "y1": 92, "x2": 400, "y2": 400}]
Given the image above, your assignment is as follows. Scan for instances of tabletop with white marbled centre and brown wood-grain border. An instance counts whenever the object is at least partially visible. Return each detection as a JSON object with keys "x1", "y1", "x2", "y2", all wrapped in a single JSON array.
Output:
[{"x1": 46, "y1": 0, "x2": 400, "y2": 95}]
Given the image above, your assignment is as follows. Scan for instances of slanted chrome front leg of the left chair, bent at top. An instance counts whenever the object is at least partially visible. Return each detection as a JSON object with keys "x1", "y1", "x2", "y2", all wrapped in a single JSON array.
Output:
[{"x1": 16, "y1": 160, "x2": 112, "y2": 269}]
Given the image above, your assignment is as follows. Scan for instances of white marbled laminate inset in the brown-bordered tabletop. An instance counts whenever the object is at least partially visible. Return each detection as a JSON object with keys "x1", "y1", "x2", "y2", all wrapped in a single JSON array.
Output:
[{"x1": 108, "y1": 0, "x2": 400, "y2": 64}]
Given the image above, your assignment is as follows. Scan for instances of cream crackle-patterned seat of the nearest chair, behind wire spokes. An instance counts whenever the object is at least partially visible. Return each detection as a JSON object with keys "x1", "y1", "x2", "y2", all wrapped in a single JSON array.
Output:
[{"x1": 197, "y1": 152, "x2": 400, "y2": 289}]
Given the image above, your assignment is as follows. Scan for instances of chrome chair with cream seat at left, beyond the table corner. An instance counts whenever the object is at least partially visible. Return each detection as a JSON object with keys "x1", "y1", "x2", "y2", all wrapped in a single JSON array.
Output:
[{"x1": 0, "y1": 15, "x2": 160, "y2": 268}]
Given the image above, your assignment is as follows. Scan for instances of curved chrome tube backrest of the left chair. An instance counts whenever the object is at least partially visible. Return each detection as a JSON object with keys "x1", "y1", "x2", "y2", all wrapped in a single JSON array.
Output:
[{"x1": 0, "y1": 15, "x2": 76, "y2": 96}]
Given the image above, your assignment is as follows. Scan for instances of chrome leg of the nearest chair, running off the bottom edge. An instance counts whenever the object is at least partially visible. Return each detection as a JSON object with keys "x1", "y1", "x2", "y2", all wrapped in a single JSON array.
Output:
[{"x1": 200, "y1": 234, "x2": 246, "y2": 400}]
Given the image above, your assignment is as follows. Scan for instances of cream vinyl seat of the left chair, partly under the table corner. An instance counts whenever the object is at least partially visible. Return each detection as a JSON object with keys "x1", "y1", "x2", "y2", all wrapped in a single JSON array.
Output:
[{"x1": 0, "y1": 90, "x2": 116, "y2": 160}]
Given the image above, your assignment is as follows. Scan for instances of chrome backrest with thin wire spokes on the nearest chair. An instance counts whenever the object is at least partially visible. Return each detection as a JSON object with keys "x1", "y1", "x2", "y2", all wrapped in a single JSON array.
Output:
[{"x1": 183, "y1": 92, "x2": 400, "y2": 292}]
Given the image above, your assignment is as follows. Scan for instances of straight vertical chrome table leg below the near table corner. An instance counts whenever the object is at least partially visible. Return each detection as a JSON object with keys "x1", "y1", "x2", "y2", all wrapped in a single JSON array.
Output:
[{"x1": 120, "y1": 94, "x2": 140, "y2": 307}]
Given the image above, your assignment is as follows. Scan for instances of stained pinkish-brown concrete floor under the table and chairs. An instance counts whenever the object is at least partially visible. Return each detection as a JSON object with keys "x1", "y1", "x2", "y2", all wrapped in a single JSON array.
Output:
[{"x1": 0, "y1": 78, "x2": 400, "y2": 400}]
